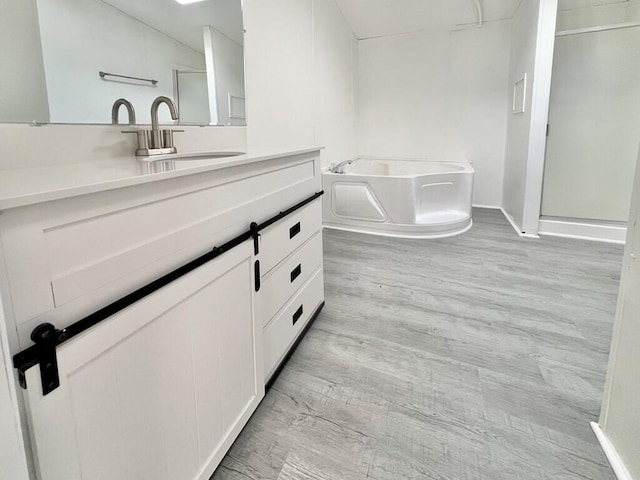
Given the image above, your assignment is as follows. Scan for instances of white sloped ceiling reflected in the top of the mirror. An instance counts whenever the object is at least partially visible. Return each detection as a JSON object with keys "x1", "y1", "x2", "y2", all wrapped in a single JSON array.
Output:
[{"x1": 100, "y1": 0, "x2": 243, "y2": 53}]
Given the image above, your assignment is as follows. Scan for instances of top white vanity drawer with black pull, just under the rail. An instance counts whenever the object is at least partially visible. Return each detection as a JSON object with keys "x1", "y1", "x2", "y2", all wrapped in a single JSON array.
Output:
[{"x1": 260, "y1": 198, "x2": 322, "y2": 273}]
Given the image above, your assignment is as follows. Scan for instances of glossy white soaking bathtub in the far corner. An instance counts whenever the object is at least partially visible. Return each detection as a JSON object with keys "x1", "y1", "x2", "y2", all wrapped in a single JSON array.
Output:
[{"x1": 322, "y1": 159, "x2": 474, "y2": 238}]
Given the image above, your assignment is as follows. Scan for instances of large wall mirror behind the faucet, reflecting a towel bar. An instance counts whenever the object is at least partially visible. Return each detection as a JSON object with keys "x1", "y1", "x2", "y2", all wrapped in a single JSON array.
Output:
[{"x1": 0, "y1": 0, "x2": 246, "y2": 125}]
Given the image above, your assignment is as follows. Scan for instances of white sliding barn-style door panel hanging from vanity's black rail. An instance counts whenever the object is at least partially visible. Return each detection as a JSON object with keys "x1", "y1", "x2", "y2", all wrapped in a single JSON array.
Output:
[{"x1": 26, "y1": 242, "x2": 264, "y2": 480}]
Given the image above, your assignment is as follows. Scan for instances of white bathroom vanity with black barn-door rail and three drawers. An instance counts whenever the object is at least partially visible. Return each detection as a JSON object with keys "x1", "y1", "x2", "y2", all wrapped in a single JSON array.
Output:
[{"x1": 0, "y1": 148, "x2": 324, "y2": 480}]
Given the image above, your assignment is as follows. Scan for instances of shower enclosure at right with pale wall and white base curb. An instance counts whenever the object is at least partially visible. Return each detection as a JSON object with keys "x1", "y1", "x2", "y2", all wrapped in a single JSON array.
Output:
[{"x1": 541, "y1": 16, "x2": 640, "y2": 241}]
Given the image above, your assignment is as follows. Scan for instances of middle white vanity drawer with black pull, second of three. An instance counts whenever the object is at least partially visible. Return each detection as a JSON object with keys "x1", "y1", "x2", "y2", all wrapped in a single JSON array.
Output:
[{"x1": 260, "y1": 233, "x2": 322, "y2": 324}]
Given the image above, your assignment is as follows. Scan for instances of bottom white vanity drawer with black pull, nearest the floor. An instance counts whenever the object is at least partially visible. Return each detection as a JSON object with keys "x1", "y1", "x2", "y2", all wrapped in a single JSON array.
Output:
[{"x1": 264, "y1": 268, "x2": 324, "y2": 381}]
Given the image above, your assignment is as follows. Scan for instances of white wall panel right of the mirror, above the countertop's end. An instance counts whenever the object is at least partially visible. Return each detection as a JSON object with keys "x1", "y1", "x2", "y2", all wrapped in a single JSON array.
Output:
[{"x1": 244, "y1": 0, "x2": 314, "y2": 147}]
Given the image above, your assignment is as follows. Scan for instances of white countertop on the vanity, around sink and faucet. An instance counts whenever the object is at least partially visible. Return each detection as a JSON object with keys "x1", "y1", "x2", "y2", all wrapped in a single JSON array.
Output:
[{"x1": 0, "y1": 147, "x2": 322, "y2": 210}]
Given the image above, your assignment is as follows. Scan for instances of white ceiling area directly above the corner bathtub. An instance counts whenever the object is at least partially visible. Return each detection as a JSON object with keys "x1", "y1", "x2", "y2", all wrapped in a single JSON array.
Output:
[{"x1": 337, "y1": 0, "x2": 524, "y2": 40}]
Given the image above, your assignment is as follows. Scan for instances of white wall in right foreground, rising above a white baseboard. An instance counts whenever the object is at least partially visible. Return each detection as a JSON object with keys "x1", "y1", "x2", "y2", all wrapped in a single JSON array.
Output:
[{"x1": 600, "y1": 144, "x2": 640, "y2": 480}]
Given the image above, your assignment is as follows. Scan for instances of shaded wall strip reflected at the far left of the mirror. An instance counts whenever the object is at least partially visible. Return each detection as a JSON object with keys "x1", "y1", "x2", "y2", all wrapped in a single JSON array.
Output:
[{"x1": 0, "y1": 0, "x2": 49, "y2": 123}]
